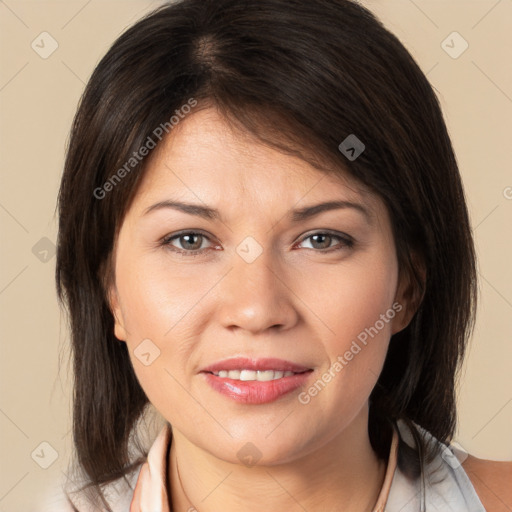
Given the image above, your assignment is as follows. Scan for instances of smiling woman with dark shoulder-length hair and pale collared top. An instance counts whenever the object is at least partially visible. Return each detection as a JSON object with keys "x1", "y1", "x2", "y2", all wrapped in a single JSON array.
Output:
[{"x1": 56, "y1": 0, "x2": 511, "y2": 512}]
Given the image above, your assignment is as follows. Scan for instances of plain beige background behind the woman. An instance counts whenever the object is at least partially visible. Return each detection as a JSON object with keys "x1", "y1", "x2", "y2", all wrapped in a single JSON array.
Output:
[{"x1": 0, "y1": 0, "x2": 512, "y2": 512}]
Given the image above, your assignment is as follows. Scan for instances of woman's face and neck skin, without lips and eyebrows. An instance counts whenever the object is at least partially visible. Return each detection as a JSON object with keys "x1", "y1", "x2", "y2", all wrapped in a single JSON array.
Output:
[{"x1": 110, "y1": 108, "x2": 413, "y2": 512}]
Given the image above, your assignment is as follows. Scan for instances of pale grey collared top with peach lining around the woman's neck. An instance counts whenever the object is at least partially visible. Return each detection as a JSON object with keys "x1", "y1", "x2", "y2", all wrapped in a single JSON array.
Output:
[{"x1": 44, "y1": 421, "x2": 486, "y2": 512}]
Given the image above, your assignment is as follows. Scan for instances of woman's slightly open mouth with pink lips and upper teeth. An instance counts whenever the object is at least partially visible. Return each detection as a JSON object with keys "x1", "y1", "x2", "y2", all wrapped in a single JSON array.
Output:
[{"x1": 201, "y1": 358, "x2": 313, "y2": 405}]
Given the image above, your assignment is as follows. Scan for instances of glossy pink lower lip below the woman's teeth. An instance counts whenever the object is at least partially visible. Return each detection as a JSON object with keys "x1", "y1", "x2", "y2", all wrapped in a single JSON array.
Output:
[{"x1": 204, "y1": 371, "x2": 312, "y2": 404}]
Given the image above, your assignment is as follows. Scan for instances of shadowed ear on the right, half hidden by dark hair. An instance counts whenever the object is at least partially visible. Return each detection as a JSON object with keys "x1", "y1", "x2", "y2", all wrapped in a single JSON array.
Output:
[{"x1": 391, "y1": 255, "x2": 426, "y2": 334}]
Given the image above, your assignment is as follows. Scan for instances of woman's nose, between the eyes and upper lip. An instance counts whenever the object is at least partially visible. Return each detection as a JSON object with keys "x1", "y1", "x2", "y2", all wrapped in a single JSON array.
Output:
[{"x1": 217, "y1": 244, "x2": 299, "y2": 334}]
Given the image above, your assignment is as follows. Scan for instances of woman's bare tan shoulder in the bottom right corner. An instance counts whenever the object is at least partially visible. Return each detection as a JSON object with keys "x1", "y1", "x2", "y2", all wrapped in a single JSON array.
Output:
[{"x1": 462, "y1": 455, "x2": 512, "y2": 512}]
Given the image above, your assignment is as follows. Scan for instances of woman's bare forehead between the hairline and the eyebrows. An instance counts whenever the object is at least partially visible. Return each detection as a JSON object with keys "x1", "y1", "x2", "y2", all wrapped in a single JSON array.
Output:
[{"x1": 130, "y1": 108, "x2": 377, "y2": 218}]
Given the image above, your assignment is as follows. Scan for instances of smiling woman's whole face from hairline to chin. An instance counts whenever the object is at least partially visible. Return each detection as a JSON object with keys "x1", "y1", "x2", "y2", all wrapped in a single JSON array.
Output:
[{"x1": 110, "y1": 109, "x2": 407, "y2": 464}]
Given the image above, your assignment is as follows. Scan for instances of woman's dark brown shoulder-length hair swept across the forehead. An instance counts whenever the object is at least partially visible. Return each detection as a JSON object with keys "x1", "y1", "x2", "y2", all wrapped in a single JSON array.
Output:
[{"x1": 56, "y1": 0, "x2": 477, "y2": 509}]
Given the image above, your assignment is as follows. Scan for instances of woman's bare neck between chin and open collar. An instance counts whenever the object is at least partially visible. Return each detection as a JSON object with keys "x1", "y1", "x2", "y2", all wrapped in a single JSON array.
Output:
[{"x1": 168, "y1": 408, "x2": 386, "y2": 512}]
